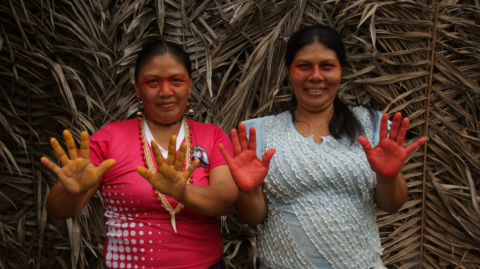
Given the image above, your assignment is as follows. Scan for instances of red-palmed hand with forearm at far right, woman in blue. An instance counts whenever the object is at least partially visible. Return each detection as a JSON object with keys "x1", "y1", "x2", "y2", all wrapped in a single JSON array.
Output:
[{"x1": 358, "y1": 112, "x2": 425, "y2": 213}]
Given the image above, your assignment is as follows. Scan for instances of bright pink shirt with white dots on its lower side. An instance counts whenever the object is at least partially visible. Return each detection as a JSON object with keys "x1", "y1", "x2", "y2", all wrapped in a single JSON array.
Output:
[{"x1": 90, "y1": 118, "x2": 233, "y2": 268}]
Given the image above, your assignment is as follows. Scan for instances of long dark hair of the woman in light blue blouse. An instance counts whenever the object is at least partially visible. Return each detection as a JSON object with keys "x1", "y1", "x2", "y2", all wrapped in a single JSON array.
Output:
[{"x1": 285, "y1": 25, "x2": 366, "y2": 144}]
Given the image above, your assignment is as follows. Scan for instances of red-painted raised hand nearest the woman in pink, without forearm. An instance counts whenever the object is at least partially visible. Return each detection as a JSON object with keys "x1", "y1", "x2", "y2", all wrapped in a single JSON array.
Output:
[{"x1": 219, "y1": 123, "x2": 275, "y2": 192}]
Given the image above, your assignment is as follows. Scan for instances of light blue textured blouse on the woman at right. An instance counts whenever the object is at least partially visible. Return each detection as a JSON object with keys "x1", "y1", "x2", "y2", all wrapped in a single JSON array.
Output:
[{"x1": 244, "y1": 107, "x2": 383, "y2": 269}]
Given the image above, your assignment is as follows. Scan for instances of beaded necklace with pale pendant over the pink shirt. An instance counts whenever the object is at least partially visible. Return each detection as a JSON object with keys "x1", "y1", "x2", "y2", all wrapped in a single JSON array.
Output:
[{"x1": 138, "y1": 114, "x2": 193, "y2": 233}]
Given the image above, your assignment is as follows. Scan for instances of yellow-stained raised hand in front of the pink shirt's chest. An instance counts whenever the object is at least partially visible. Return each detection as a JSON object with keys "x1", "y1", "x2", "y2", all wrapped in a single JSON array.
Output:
[{"x1": 137, "y1": 135, "x2": 200, "y2": 201}]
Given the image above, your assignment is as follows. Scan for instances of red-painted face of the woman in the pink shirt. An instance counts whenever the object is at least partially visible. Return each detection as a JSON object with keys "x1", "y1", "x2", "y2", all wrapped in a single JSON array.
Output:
[{"x1": 135, "y1": 54, "x2": 192, "y2": 124}]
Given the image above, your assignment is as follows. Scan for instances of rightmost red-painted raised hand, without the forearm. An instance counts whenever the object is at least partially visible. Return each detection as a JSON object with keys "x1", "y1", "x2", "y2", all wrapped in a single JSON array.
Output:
[{"x1": 358, "y1": 112, "x2": 425, "y2": 178}]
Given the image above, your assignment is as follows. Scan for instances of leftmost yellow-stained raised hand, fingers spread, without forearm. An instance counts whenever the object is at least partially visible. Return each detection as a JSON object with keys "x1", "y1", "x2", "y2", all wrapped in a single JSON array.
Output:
[{"x1": 40, "y1": 130, "x2": 115, "y2": 195}]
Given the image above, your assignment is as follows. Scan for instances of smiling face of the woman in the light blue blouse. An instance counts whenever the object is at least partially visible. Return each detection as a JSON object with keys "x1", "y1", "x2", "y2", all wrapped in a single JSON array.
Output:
[{"x1": 288, "y1": 42, "x2": 342, "y2": 112}]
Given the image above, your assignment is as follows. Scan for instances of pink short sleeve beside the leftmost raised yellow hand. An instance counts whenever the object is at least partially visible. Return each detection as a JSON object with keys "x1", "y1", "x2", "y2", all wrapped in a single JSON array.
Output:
[{"x1": 89, "y1": 125, "x2": 112, "y2": 181}]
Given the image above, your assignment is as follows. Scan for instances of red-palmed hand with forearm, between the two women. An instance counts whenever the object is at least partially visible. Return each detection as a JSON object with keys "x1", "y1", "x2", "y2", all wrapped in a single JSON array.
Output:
[{"x1": 219, "y1": 123, "x2": 275, "y2": 225}]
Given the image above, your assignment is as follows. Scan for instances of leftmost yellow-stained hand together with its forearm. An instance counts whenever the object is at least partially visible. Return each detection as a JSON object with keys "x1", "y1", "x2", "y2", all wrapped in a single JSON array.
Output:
[{"x1": 40, "y1": 130, "x2": 115, "y2": 219}]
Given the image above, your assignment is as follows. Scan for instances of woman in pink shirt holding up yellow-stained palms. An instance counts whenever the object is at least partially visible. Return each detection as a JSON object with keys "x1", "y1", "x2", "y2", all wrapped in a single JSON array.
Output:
[{"x1": 41, "y1": 40, "x2": 238, "y2": 269}]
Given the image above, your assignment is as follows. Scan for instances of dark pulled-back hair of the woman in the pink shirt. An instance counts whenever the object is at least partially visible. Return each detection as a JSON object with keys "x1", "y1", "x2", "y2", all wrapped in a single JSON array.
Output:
[{"x1": 135, "y1": 40, "x2": 192, "y2": 81}]
